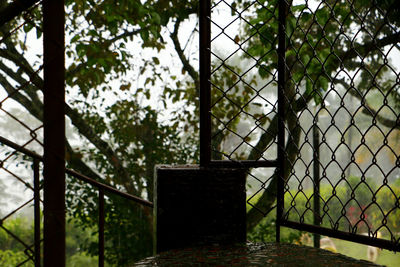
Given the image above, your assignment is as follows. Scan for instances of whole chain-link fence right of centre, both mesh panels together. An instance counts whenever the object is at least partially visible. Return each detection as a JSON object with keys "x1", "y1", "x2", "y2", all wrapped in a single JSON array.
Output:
[{"x1": 202, "y1": 0, "x2": 400, "y2": 250}]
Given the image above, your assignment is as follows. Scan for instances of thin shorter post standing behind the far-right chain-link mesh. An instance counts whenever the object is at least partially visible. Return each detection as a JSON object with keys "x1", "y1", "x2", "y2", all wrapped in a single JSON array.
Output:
[{"x1": 313, "y1": 113, "x2": 321, "y2": 248}]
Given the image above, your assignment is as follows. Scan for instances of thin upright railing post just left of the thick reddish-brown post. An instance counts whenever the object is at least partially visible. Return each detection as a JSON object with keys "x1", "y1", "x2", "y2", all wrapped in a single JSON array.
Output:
[{"x1": 33, "y1": 159, "x2": 41, "y2": 267}]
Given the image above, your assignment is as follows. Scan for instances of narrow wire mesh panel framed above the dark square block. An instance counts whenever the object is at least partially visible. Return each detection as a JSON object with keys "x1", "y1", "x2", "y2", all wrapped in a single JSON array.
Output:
[{"x1": 211, "y1": 1, "x2": 277, "y2": 164}]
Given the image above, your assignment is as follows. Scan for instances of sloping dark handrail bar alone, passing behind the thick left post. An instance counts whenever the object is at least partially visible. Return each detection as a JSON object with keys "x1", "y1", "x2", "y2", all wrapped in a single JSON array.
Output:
[{"x1": 0, "y1": 136, "x2": 153, "y2": 207}]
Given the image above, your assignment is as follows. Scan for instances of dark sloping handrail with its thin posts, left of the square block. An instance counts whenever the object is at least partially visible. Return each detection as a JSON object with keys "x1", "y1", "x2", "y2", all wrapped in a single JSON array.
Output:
[{"x1": 0, "y1": 136, "x2": 153, "y2": 266}]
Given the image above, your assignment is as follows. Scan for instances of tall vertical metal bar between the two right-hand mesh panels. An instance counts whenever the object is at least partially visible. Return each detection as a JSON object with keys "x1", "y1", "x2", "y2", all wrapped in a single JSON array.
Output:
[{"x1": 276, "y1": 0, "x2": 287, "y2": 242}]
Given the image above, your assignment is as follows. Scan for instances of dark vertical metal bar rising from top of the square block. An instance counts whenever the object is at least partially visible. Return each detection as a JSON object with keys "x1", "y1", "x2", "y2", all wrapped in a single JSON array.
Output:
[{"x1": 199, "y1": 0, "x2": 211, "y2": 167}]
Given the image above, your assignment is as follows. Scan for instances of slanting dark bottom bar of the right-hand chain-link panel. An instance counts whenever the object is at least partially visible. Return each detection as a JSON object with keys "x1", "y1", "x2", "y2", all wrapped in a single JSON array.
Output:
[{"x1": 281, "y1": 220, "x2": 400, "y2": 252}]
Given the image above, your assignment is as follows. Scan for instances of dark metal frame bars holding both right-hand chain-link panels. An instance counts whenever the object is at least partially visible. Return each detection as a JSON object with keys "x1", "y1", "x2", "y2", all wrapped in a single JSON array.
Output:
[{"x1": 199, "y1": 0, "x2": 400, "y2": 251}]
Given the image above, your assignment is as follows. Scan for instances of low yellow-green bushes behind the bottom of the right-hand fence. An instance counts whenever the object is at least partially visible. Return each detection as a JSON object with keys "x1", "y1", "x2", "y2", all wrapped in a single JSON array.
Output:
[{"x1": 248, "y1": 179, "x2": 400, "y2": 243}]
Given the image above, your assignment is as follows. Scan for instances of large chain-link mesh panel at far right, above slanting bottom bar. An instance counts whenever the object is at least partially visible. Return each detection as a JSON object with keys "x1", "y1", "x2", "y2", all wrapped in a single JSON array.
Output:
[{"x1": 284, "y1": 1, "x2": 400, "y2": 251}]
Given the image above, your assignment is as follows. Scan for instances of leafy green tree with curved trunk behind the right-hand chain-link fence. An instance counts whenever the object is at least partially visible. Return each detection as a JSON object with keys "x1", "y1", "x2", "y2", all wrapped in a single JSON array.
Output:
[{"x1": 220, "y1": 1, "x2": 400, "y2": 230}]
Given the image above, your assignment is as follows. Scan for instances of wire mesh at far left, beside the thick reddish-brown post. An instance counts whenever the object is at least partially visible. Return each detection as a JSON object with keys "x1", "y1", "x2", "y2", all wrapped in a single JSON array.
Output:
[{"x1": 0, "y1": 3, "x2": 43, "y2": 266}]
